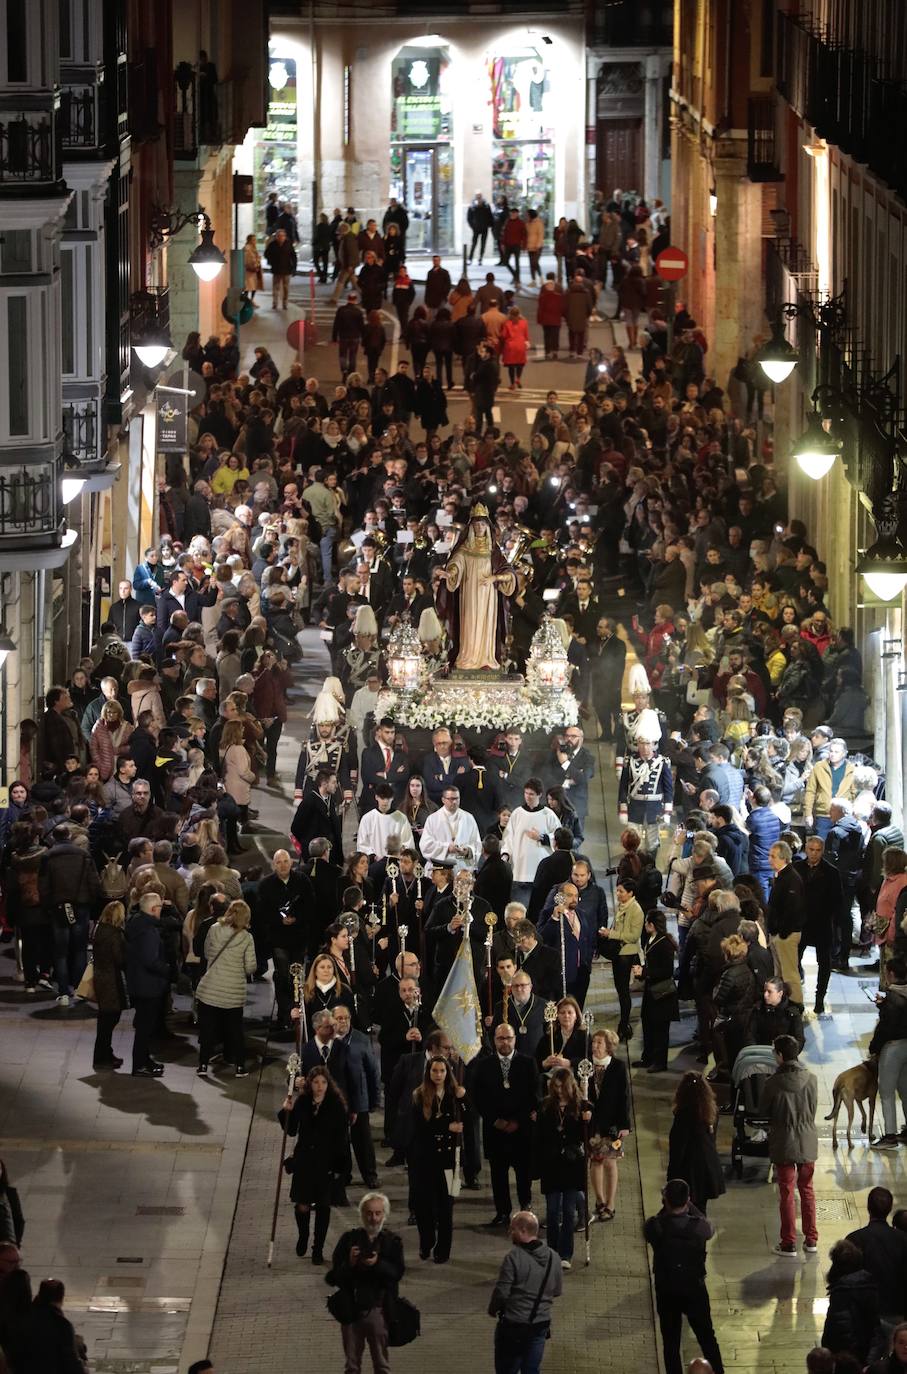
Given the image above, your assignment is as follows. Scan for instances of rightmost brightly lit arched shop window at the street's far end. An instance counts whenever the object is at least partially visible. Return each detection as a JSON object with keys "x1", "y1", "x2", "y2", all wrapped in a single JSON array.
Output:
[{"x1": 488, "y1": 48, "x2": 554, "y2": 227}]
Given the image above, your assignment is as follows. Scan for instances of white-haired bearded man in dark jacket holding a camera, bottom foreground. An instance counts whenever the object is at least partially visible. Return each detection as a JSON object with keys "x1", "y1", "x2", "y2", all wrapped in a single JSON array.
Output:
[{"x1": 326, "y1": 1193, "x2": 405, "y2": 1374}]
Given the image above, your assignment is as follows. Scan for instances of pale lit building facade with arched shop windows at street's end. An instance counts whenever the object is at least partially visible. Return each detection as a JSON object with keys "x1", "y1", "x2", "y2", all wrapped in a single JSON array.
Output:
[{"x1": 251, "y1": 3, "x2": 587, "y2": 254}]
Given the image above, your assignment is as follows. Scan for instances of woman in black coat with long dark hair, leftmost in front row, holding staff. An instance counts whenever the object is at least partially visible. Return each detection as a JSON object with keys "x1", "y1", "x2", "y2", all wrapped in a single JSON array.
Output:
[{"x1": 278, "y1": 1063, "x2": 350, "y2": 1264}]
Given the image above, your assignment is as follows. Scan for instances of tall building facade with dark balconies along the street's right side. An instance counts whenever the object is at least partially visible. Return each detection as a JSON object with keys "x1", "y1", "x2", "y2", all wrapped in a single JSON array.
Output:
[{"x1": 671, "y1": 0, "x2": 907, "y2": 819}]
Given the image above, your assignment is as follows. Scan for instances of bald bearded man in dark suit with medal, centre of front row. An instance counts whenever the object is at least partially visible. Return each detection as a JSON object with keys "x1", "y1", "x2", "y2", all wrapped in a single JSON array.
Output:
[{"x1": 473, "y1": 1022, "x2": 539, "y2": 1227}]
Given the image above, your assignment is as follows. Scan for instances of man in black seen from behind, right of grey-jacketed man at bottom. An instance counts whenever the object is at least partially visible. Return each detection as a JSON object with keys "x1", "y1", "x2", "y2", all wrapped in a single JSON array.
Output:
[{"x1": 645, "y1": 1179, "x2": 724, "y2": 1374}]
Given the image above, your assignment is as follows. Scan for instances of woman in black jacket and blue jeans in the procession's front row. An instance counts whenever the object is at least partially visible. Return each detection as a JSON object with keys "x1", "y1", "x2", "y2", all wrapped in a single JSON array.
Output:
[{"x1": 533, "y1": 1069, "x2": 592, "y2": 1270}]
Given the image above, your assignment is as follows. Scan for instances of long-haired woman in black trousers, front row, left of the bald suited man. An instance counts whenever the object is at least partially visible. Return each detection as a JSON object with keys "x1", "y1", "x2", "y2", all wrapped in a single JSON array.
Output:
[{"x1": 407, "y1": 1055, "x2": 466, "y2": 1264}]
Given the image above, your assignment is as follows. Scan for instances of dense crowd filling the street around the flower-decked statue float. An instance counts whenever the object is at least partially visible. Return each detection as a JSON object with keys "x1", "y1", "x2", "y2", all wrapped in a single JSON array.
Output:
[{"x1": 0, "y1": 207, "x2": 907, "y2": 1374}]
